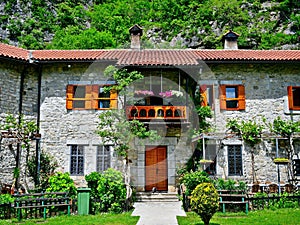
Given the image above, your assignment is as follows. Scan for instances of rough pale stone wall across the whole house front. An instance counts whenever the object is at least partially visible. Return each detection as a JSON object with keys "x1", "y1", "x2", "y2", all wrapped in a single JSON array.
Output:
[{"x1": 0, "y1": 59, "x2": 300, "y2": 190}]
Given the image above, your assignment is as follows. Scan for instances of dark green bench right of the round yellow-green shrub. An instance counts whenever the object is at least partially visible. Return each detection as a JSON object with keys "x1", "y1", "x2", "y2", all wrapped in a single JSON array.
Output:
[{"x1": 219, "y1": 193, "x2": 249, "y2": 214}]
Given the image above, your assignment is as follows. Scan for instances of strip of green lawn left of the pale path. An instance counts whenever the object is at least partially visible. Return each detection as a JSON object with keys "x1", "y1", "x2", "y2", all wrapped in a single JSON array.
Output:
[{"x1": 0, "y1": 212, "x2": 139, "y2": 225}]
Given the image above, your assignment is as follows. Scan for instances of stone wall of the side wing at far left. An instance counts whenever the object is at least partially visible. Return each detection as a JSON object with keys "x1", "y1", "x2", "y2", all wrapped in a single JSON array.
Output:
[{"x1": 0, "y1": 60, "x2": 38, "y2": 188}]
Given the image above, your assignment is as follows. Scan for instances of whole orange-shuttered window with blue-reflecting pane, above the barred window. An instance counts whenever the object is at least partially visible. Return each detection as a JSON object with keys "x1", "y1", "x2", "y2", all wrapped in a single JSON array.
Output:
[{"x1": 220, "y1": 85, "x2": 246, "y2": 110}]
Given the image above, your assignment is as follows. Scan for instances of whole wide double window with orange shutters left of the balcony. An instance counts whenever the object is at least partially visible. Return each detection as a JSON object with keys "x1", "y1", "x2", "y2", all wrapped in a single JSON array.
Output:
[{"x1": 66, "y1": 85, "x2": 118, "y2": 109}]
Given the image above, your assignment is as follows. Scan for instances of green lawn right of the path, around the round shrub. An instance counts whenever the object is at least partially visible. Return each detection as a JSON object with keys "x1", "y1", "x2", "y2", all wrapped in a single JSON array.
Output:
[{"x1": 177, "y1": 208, "x2": 300, "y2": 225}]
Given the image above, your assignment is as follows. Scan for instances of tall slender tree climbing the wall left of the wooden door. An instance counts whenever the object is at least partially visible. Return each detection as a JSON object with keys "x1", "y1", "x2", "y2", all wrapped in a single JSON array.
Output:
[{"x1": 97, "y1": 66, "x2": 159, "y2": 210}]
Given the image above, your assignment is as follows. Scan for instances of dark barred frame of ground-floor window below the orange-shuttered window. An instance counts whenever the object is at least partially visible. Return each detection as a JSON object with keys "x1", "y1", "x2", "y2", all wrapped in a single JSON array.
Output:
[{"x1": 227, "y1": 145, "x2": 243, "y2": 176}]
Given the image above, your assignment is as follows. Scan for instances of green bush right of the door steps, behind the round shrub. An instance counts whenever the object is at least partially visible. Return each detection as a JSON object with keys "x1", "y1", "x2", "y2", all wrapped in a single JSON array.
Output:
[{"x1": 180, "y1": 171, "x2": 212, "y2": 196}]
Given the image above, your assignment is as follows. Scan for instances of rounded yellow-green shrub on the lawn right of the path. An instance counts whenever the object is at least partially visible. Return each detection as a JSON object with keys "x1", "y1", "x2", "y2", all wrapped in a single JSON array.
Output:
[{"x1": 191, "y1": 183, "x2": 219, "y2": 225}]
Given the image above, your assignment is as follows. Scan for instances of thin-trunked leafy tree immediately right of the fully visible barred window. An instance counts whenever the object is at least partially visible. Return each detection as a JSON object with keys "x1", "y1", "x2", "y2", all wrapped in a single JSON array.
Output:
[{"x1": 226, "y1": 119, "x2": 264, "y2": 182}]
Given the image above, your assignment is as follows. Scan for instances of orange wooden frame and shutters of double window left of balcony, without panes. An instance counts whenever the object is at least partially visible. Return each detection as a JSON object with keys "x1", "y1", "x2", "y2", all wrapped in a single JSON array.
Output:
[{"x1": 66, "y1": 84, "x2": 118, "y2": 110}]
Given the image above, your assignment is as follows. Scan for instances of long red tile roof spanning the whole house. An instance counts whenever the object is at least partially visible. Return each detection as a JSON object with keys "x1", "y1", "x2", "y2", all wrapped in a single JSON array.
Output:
[{"x1": 0, "y1": 43, "x2": 300, "y2": 66}]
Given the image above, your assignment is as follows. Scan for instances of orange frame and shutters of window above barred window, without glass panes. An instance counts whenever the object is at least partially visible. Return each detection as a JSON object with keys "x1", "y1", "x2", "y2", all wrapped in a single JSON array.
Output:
[{"x1": 219, "y1": 84, "x2": 246, "y2": 111}]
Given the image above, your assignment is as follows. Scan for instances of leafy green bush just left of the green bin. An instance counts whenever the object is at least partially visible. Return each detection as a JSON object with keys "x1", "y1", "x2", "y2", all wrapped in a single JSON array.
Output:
[{"x1": 46, "y1": 172, "x2": 77, "y2": 198}]
